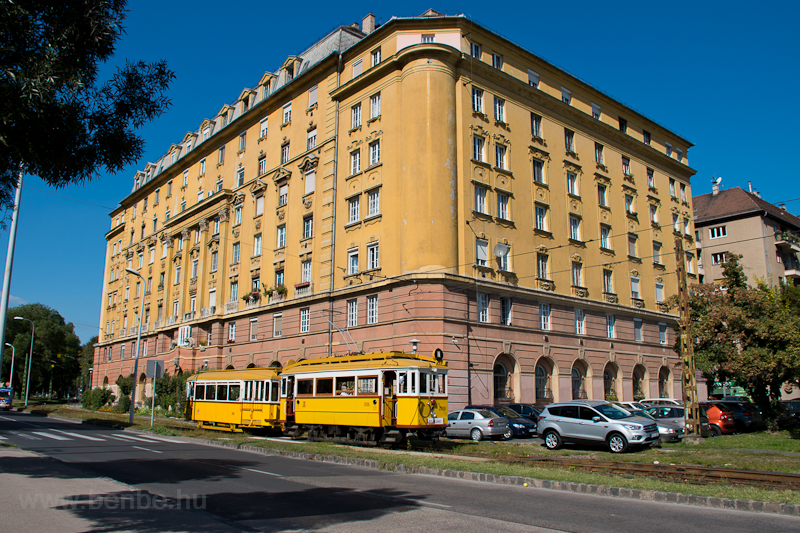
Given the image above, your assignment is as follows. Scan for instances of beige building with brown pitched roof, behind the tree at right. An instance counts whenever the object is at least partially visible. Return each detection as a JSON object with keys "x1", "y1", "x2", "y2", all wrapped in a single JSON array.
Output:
[{"x1": 692, "y1": 184, "x2": 800, "y2": 285}]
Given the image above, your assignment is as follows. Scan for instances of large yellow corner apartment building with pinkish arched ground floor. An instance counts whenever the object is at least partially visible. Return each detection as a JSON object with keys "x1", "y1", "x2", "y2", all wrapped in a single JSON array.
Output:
[{"x1": 94, "y1": 11, "x2": 697, "y2": 406}]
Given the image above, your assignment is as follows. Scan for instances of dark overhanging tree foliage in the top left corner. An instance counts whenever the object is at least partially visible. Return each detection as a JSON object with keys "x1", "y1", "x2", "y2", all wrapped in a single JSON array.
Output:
[{"x1": 0, "y1": 0, "x2": 174, "y2": 207}]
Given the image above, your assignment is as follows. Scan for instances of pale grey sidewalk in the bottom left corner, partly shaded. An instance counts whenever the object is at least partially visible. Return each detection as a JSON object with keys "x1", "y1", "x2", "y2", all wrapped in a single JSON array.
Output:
[{"x1": 0, "y1": 446, "x2": 238, "y2": 533}]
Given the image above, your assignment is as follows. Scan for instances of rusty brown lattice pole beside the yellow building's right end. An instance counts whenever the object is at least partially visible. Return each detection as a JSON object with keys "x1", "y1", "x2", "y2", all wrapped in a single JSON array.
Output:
[{"x1": 675, "y1": 236, "x2": 703, "y2": 444}]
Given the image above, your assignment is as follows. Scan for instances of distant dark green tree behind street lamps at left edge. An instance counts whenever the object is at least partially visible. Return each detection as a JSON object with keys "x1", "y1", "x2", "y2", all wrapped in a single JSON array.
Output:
[{"x1": 3, "y1": 304, "x2": 81, "y2": 395}]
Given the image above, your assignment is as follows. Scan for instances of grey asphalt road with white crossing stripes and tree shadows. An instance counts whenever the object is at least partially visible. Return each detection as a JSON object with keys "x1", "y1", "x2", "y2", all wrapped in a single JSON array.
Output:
[{"x1": 0, "y1": 412, "x2": 800, "y2": 533}]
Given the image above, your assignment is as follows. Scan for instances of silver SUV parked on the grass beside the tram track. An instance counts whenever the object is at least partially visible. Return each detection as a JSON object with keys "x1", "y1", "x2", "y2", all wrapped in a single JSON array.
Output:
[{"x1": 539, "y1": 400, "x2": 658, "y2": 453}]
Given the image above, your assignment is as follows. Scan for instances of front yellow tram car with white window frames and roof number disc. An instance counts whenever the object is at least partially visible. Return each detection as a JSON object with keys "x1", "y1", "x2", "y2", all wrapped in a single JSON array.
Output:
[{"x1": 281, "y1": 349, "x2": 448, "y2": 444}]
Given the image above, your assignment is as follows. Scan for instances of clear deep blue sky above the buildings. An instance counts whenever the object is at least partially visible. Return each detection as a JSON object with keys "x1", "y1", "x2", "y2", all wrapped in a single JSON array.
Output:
[{"x1": 0, "y1": 0, "x2": 800, "y2": 341}]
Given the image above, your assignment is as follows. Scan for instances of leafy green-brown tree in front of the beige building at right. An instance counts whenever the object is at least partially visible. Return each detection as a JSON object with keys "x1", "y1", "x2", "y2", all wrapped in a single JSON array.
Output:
[{"x1": 690, "y1": 253, "x2": 800, "y2": 425}]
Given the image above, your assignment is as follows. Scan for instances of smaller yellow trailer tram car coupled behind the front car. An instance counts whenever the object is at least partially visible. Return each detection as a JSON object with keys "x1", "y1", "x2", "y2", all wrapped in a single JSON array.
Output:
[{"x1": 186, "y1": 368, "x2": 281, "y2": 432}]
